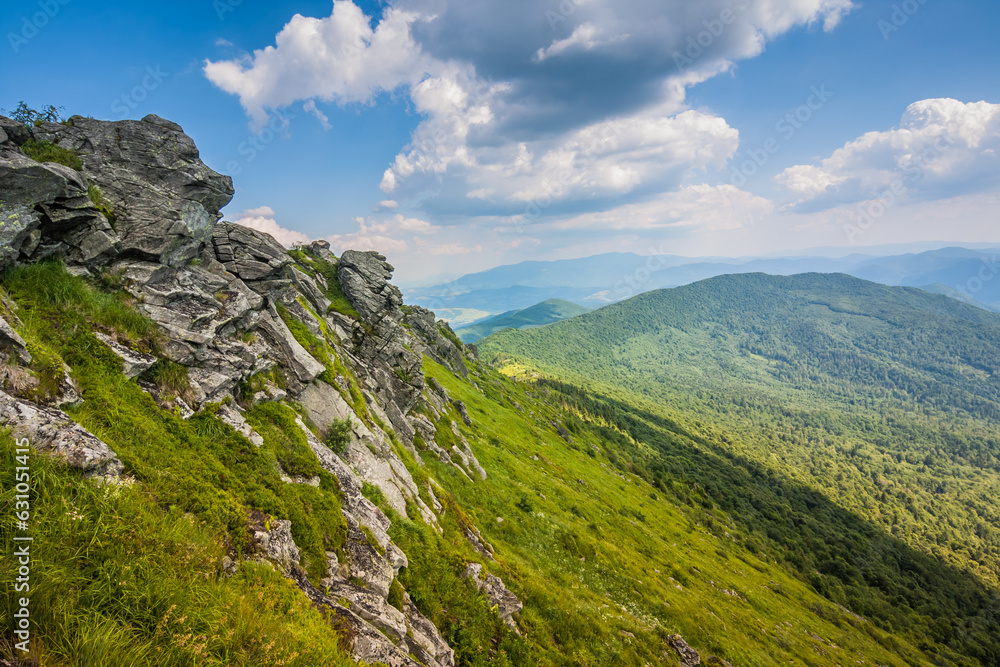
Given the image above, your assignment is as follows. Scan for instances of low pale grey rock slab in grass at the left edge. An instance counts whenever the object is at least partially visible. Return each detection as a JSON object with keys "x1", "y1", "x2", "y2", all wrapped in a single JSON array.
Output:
[{"x1": 0, "y1": 392, "x2": 124, "y2": 481}]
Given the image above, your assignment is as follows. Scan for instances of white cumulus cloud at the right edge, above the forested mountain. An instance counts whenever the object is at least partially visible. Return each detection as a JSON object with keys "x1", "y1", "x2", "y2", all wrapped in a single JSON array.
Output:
[{"x1": 775, "y1": 99, "x2": 1000, "y2": 210}]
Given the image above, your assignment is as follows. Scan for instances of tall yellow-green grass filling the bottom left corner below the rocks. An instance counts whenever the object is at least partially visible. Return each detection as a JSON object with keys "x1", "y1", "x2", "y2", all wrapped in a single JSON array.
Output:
[{"x1": 0, "y1": 434, "x2": 354, "y2": 667}]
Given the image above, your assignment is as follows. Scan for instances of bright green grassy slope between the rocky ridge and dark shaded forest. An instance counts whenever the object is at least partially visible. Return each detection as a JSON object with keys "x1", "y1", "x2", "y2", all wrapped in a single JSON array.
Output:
[{"x1": 411, "y1": 362, "x2": 940, "y2": 667}]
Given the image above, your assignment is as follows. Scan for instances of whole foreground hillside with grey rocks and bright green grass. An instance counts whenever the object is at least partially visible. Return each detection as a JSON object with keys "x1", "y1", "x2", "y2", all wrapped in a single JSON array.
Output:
[{"x1": 0, "y1": 116, "x2": 980, "y2": 667}]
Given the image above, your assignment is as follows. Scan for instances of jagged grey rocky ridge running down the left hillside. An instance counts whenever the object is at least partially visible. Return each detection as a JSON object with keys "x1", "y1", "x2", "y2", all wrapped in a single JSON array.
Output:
[{"x1": 0, "y1": 116, "x2": 521, "y2": 667}]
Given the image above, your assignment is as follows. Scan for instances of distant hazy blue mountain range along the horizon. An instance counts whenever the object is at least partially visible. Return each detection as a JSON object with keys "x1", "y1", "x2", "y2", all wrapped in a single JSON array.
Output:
[{"x1": 406, "y1": 247, "x2": 1000, "y2": 324}]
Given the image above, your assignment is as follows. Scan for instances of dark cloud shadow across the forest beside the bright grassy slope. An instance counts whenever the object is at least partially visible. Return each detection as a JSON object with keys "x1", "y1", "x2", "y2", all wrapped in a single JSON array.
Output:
[{"x1": 543, "y1": 381, "x2": 1000, "y2": 667}]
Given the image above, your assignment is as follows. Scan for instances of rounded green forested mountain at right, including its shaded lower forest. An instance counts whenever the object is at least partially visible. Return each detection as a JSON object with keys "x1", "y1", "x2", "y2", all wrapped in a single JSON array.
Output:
[{"x1": 478, "y1": 274, "x2": 1000, "y2": 665}]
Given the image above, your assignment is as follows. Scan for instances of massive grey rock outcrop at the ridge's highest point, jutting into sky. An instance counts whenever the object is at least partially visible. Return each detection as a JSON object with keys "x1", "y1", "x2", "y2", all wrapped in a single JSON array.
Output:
[{"x1": 33, "y1": 115, "x2": 233, "y2": 265}]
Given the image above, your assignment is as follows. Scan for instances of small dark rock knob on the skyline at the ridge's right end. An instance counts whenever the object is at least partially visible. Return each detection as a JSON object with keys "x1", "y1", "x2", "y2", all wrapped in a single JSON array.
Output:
[{"x1": 338, "y1": 250, "x2": 403, "y2": 326}]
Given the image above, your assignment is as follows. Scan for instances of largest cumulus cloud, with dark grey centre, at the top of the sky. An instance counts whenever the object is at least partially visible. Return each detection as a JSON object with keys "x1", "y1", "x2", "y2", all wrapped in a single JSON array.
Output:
[{"x1": 205, "y1": 0, "x2": 854, "y2": 215}]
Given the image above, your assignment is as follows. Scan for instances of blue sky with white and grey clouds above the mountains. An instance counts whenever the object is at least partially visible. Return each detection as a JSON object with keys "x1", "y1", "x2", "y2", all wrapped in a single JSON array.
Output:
[{"x1": 0, "y1": 0, "x2": 1000, "y2": 285}]
